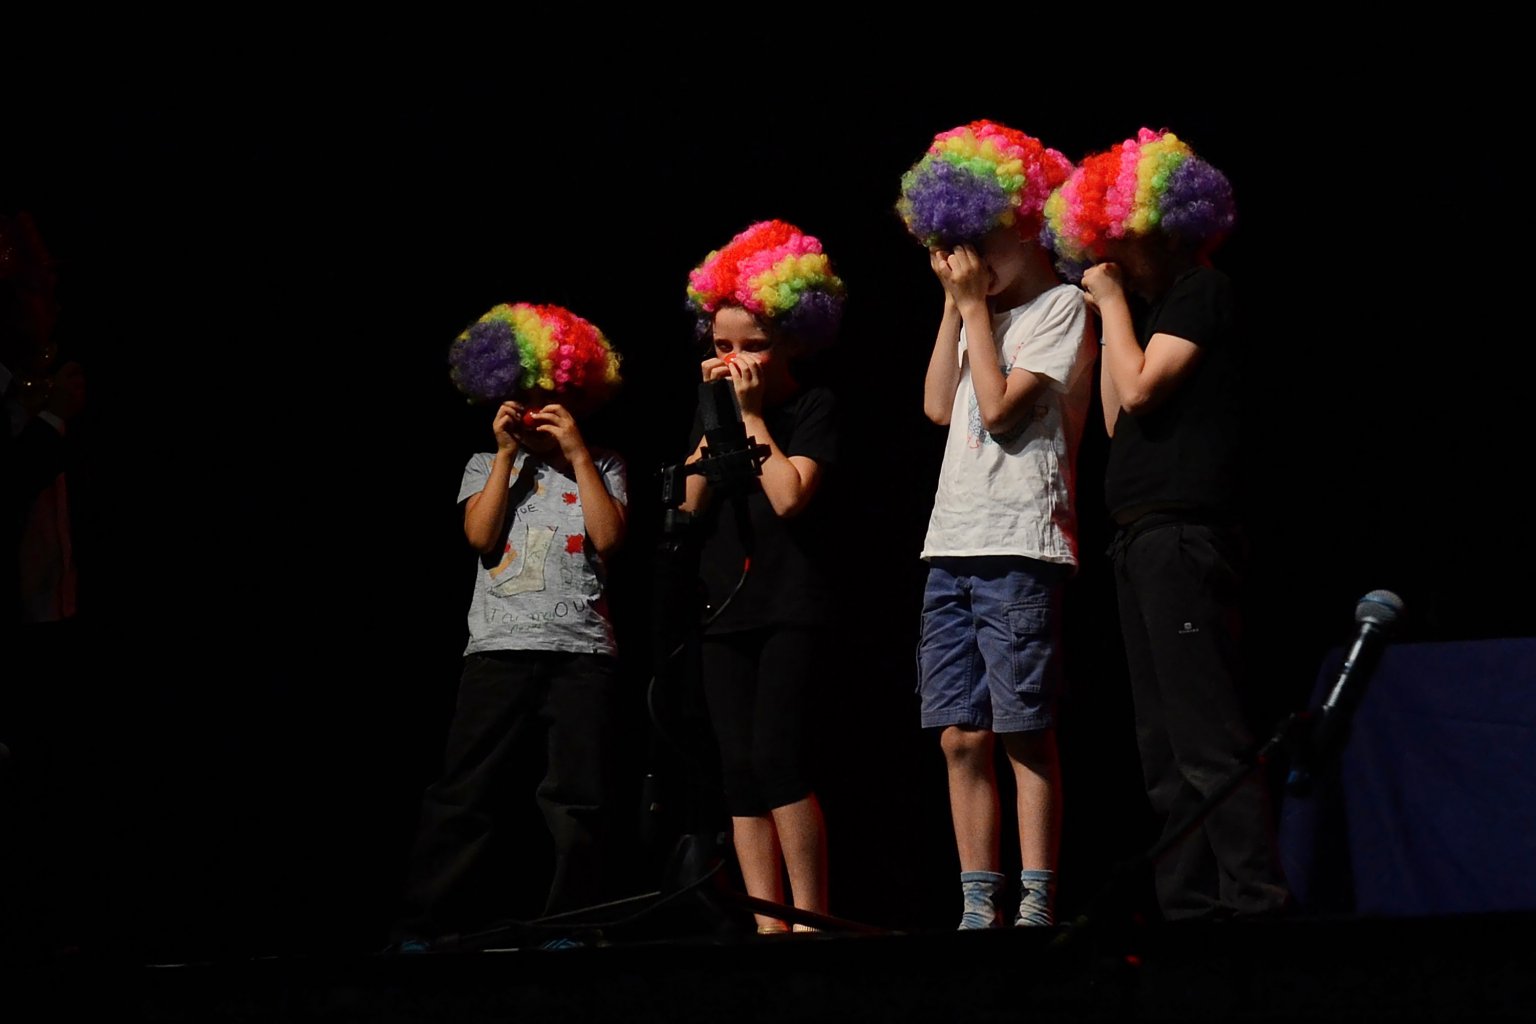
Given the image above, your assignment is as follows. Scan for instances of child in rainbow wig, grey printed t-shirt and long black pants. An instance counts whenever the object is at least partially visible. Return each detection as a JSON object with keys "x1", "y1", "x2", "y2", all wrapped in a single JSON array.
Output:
[{"x1": 395, "y1": 302, "x2": 627, "y2": 949}]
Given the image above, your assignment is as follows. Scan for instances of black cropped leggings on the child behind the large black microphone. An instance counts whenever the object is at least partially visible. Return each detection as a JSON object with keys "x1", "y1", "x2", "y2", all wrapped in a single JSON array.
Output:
[{"x1": 702, "y1": 626, "x2": 823, "y2": 817}]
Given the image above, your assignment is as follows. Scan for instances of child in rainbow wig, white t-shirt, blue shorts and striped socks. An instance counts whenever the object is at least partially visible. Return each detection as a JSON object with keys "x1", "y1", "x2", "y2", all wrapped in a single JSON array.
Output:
[{"x1": 897, "y1": 121, "x2": 1097, "y2": 929}]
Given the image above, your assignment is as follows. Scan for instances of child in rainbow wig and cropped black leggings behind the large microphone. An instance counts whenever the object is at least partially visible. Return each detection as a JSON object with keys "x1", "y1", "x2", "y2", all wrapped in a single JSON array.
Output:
[{"x1": 682, "y1": 220, "x2": 843, "y2": 932}]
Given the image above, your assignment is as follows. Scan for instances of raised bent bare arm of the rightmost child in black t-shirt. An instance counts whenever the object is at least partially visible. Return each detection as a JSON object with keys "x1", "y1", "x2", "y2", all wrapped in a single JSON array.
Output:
[{"x1": 1083, "y1": 263, "x2": 1200, "y2": 417}]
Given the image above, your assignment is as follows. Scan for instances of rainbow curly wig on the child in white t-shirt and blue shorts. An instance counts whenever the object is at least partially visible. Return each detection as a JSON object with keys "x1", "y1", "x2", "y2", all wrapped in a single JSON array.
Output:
[{"x1": 895, "y1": 121, "x2": 1072, "y2": 249}]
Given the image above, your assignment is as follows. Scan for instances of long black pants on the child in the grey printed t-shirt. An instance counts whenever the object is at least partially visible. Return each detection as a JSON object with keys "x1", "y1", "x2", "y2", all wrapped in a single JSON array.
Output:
[{"x1": 395, "y1": 651, "x2": 617, "y2": 938}]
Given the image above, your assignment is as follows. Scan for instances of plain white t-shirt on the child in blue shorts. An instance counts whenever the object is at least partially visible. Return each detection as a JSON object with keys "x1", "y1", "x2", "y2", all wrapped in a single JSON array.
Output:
[{"x1": 922, "y1": 284, "x2": 1098, "y2": 565}]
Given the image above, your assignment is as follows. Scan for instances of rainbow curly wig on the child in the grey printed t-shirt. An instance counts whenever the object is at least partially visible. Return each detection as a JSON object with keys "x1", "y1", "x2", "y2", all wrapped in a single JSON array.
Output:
[{"x1": 449, "y1": 302, "x2": 619, "y2": 410}]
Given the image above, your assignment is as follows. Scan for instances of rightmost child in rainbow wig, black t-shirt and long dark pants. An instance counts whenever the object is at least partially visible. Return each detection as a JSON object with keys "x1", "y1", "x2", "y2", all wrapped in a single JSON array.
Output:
[{"x1": 1046, "y1": 129, "x2": 1289, "y2": 920}]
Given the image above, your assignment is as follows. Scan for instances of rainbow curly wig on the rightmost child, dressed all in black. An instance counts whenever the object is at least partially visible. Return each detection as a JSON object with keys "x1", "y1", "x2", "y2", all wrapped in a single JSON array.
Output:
[{"x1": 1046, "y1": 127, "x2": 1236, "y2": 281}]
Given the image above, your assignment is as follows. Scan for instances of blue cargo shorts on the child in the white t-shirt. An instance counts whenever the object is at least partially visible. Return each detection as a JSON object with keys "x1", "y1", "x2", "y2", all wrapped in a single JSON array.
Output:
[{"x1": 917, "y1": 556, "x2": 1069, "y2": 732}]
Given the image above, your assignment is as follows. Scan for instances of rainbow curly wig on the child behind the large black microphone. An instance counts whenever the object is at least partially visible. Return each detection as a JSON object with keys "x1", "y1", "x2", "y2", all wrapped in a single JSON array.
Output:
[{"x1": 688, "y1": 221, "x2": 843, "y2": 347}]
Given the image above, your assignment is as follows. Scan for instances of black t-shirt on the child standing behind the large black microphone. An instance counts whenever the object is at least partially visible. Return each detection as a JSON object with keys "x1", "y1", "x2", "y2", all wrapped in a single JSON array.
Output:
[{"x1": 688, "y1": 387, "x2": 837, "y2": 633}]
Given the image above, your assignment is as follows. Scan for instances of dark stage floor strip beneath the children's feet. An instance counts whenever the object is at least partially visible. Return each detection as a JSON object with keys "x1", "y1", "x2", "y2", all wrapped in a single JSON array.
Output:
[{"x1": 24, "y1": 913, "x2": 1536, "y2": 1022}]
